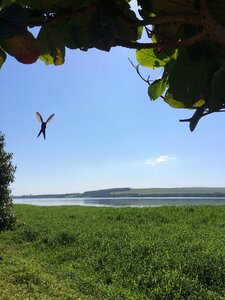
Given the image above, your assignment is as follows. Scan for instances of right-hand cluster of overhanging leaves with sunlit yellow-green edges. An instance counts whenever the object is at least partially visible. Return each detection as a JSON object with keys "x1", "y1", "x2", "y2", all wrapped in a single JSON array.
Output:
[{"x1": 136, "y1": 0, "x2": 225, "y2": 131}]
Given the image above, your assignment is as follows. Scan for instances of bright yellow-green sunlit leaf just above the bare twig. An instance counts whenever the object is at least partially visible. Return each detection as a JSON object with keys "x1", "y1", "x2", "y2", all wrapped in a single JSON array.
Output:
[{"x1": 136, "y1": 49, "x2": 169, "y2": 69}]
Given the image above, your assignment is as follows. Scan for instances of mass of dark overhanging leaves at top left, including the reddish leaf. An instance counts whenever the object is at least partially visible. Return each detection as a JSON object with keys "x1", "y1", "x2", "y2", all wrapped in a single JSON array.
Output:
[{"x1": 0, "y1": 0, "x2": 140, "y2": 65}]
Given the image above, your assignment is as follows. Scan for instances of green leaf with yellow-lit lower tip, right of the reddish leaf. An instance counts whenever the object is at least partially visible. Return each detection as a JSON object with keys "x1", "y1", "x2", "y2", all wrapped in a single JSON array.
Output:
[{"x1": 37, "y1": 25, "x2": 65, "y2": 66}]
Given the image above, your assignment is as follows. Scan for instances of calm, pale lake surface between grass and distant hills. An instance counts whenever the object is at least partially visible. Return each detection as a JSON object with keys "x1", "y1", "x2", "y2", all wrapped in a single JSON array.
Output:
[{"x1": 13, "y1": 197, "x2": 225, "y2": 207}]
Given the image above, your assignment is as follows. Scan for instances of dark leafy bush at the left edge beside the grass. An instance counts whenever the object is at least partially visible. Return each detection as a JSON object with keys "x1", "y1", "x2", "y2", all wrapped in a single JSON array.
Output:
[{"x1": 0, "y1": 132, "x2": 16, "y2": 231}]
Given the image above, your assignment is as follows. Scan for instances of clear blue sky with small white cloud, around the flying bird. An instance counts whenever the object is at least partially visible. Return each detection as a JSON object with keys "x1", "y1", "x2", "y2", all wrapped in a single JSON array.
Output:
[{"x1": 0, "y1": 32, "x2": 225, "y2": 195}]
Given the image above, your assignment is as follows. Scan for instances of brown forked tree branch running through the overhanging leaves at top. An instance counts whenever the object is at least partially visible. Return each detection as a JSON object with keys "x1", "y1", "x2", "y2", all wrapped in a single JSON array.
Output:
[{"x1": 25, "y1": 0, "x2": 225, "y2": 49}]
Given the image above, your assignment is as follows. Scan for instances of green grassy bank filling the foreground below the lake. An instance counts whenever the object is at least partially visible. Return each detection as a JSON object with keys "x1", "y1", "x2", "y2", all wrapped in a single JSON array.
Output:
[{"x1": 0, "y1": 205, "x2": 225, "y2": 300}]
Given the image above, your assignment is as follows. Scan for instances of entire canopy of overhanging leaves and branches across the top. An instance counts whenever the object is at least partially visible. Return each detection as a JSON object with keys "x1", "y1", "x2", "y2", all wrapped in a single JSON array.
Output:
[{"x1": 0, "y1": 0, "x2": 225, "y2": 131}]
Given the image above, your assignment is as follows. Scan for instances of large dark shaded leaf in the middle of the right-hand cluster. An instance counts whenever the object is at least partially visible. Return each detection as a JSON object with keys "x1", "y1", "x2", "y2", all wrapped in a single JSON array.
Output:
[{"x1": 168, "y1": 50, "x2": 215, "y2": 108}]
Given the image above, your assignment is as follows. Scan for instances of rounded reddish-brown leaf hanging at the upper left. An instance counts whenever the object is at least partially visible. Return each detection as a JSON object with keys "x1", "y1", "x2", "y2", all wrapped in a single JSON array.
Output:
[{"x1": 2, "y1": 31, "x2": 40, "y2": 64}]
